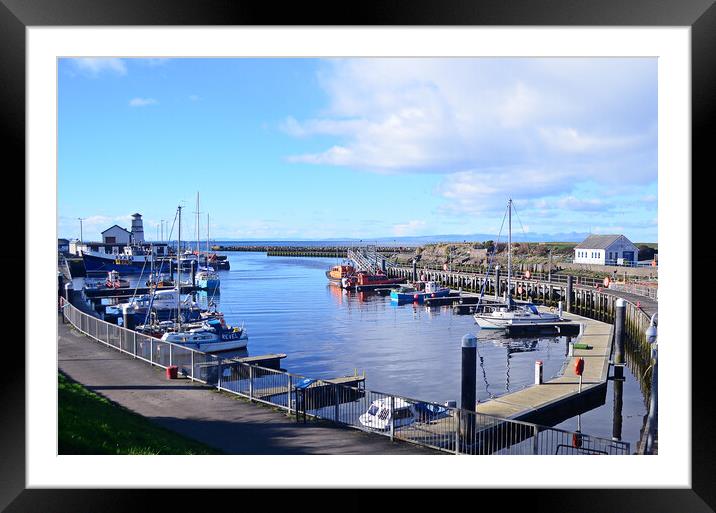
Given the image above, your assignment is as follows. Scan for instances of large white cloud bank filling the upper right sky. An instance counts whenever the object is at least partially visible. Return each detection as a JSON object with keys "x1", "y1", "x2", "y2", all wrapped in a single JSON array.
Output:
[{"x1": 281, "y1": 58, "x2": 657, "y2": 182}]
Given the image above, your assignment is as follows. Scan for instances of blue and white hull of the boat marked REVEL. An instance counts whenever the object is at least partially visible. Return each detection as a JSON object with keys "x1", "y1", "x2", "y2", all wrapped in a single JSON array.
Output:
[{"x1": 161, "y1": 319, "x2": 248, "y2": 352}]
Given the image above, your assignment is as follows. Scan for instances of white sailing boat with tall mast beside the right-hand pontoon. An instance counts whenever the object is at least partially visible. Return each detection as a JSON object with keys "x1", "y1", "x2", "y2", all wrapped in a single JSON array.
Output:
[{"x1": 474, "y1": 198, "x2": 563, "y2": 330}]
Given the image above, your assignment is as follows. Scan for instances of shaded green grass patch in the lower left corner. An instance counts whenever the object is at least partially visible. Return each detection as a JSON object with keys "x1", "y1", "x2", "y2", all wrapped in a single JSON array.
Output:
[{"x1": 57, "y1": 373, "x2": 221, "y2": 454}]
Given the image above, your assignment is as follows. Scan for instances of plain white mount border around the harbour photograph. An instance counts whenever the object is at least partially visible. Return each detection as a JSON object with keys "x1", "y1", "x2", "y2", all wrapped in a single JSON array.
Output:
[{"x1": 26, "y1": 27, "x2": 691, "y2": 488}]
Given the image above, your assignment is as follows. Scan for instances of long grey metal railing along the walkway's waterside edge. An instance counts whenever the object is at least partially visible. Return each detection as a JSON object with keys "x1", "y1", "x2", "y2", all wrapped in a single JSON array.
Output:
[{"x1": 62, "y1": 302, "x2": 630, "y2": 455}]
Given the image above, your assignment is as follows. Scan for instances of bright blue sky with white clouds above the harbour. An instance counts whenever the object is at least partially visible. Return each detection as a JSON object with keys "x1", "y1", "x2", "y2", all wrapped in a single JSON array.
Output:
[{"x1": 58, "y1": 58, "x2": 657, "y2": 242}]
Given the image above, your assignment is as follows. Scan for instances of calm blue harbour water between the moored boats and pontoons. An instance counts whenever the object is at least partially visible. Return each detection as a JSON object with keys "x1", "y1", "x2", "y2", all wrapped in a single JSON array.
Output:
[{"x1": 78, "y1": 248, "x2": 646, "y2": 448}]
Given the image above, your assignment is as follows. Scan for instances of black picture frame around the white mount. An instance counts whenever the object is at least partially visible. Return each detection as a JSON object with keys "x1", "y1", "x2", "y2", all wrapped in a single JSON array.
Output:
[{"x1": 0, "y1": 0, "x2": 716, "y2": 513}]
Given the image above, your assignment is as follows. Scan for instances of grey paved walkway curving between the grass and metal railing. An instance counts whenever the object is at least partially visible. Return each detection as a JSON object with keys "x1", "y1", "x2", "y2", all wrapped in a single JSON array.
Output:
[{"x1": 58, "y1": 319, "x2": 442, "y2": 455}]
